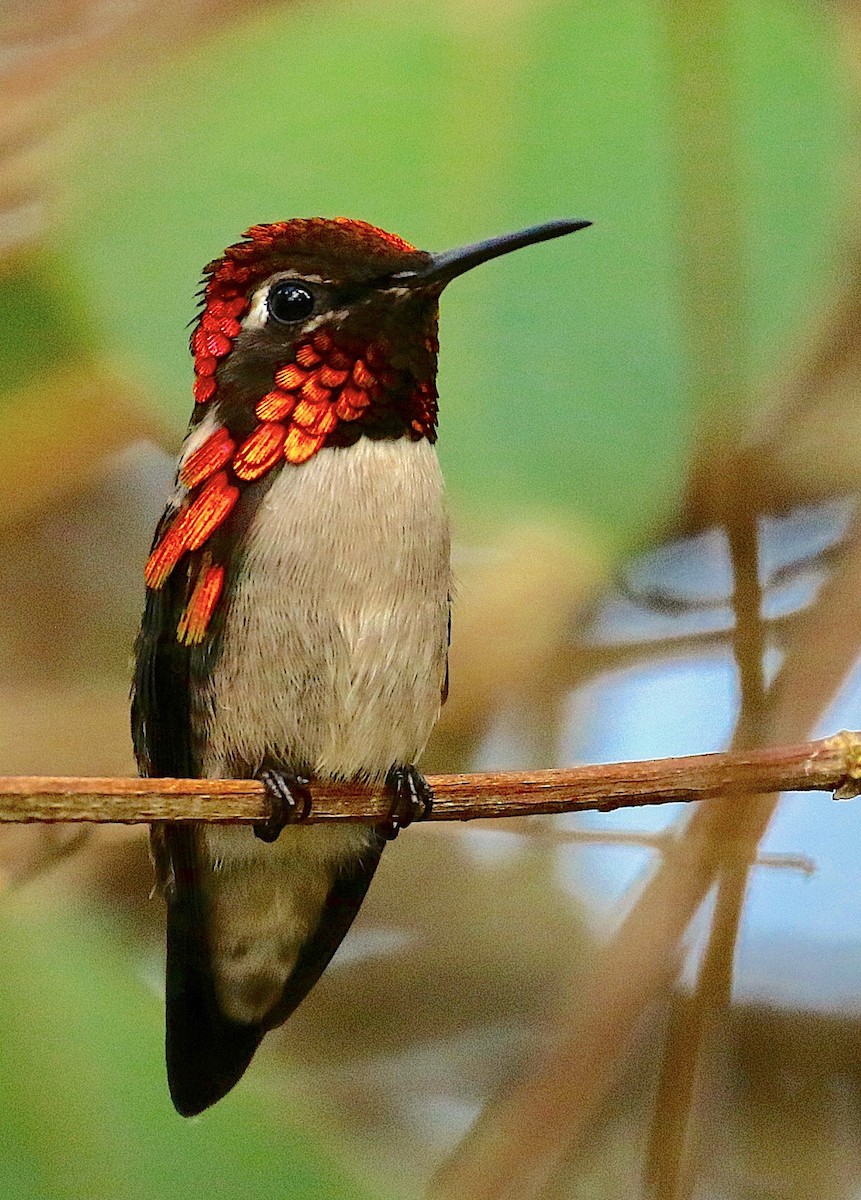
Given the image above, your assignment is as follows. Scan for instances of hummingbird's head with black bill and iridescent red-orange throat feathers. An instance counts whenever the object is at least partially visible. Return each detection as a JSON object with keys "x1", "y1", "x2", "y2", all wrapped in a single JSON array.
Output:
[{"x1": 146, "y1": 217, "x2": 589, "y2": 643}]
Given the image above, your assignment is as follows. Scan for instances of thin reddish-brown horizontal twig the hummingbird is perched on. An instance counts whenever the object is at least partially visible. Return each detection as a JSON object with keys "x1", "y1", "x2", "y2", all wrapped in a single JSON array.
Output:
[{"x1": 0, "y1": 732, "x2": 861, "y2": 824}]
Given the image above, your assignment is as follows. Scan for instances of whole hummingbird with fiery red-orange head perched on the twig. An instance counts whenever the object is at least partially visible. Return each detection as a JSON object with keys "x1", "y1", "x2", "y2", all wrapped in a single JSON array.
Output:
[{"x1": 132, "y1": 217, "x2": 590, "y2": 1116}]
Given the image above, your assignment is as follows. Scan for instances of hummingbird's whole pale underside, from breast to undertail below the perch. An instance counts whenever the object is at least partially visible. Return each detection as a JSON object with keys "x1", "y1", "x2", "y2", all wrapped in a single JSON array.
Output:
[{"x1": 193, "y1": 438, "x2": 450, "y2": 1021}]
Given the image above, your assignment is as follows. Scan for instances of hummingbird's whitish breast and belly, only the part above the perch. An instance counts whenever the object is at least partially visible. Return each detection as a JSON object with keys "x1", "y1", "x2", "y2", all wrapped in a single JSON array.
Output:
[{"x1": 198, "y1": 438, "x2": 450, "y2": 779}]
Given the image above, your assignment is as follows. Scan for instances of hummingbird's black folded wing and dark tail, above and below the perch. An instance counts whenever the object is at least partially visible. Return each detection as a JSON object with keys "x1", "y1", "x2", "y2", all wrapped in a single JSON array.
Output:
[{"x1": 132, "y1": 513, "x2": 385, "y2": 1116}]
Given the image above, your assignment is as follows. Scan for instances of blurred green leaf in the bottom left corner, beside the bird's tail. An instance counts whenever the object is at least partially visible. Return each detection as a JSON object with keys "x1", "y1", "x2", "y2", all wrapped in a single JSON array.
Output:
[{"x1": 0, "y1": 896, "x2": 388, "y2": 1200}]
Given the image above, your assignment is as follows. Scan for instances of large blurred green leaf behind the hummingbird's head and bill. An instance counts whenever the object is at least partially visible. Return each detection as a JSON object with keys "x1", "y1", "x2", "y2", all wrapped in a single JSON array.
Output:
[{"x1": 66, "y1": 0, "x2": 849, "y2": 542}]
